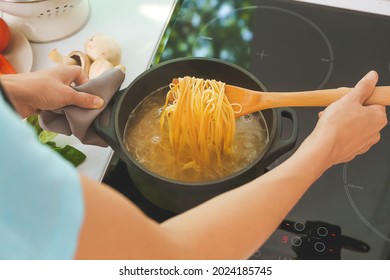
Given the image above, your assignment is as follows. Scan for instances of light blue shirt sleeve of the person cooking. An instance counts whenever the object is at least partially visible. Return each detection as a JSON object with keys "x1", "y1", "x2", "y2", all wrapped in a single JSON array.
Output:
[{"x1": 0, "y1": 91, "x2": 84, "y2": 260}]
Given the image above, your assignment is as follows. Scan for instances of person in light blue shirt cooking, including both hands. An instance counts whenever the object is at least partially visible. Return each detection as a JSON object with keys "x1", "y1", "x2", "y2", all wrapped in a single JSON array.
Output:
[{"x1": 0, "y1": 66, "x2": 387, "y2": 259}]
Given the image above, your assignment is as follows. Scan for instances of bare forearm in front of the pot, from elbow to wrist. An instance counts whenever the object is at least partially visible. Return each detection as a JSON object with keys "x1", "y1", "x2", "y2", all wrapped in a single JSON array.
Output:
[{"x1": 163, "y1": 130, "x2": 330, "y2": 259}]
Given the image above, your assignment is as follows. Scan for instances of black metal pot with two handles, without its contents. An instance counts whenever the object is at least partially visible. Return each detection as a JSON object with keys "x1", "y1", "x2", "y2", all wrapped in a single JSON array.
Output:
[{"x1": 95, "y1": 58, "x2": 298, "y2": 213}]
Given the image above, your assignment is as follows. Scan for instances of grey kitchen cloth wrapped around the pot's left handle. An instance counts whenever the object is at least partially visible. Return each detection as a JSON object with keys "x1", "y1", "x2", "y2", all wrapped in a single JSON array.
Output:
[{"x1": 39, "y1": 68, "x2": 125, "y2": 147}]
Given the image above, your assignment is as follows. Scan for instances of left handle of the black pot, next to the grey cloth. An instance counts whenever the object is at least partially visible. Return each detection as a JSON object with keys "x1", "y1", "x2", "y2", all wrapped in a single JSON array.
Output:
[{"x1": 94, "y1": 89, "x2": 125, "y2": 151}]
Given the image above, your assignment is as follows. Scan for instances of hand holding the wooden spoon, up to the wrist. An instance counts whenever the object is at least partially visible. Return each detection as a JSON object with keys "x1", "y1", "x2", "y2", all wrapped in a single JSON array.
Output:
[{"x1": 312, "y1": 71, "x2": 387, "y2": 167}]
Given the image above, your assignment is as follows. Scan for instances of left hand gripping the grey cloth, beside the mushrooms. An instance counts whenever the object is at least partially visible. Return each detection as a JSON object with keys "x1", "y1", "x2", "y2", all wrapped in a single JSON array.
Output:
[{"x1": 1, "y1": 66, "x2": 104, "y2": 117}]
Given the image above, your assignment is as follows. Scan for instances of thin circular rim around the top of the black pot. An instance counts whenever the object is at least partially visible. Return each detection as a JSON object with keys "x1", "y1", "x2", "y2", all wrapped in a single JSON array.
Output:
[{"x1": 114, "y1": 57, "x2": 277, "y2": 187}]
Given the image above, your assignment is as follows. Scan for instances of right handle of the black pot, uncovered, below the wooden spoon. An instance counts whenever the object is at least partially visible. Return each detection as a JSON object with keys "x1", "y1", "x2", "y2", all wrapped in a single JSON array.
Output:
[{"x1": 264, "y1": 107, "x2": 298, "y2": 165}]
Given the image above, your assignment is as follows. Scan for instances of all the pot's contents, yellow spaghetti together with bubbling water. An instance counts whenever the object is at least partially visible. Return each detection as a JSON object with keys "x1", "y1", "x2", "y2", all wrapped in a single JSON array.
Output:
[{"x1": 124, "y1": 77, "x2": 268, "y2": 181}]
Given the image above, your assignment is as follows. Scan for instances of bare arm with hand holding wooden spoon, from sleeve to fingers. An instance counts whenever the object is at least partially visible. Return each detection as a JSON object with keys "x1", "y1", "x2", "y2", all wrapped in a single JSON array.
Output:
[{"x1": 76, "y1": 72, "x2": 387, "y2": 259}]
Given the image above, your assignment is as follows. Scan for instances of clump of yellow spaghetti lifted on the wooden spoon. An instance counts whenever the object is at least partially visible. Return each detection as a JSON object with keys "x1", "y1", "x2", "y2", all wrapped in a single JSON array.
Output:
[{"x1": 160, "y1": 77, "x2": 239, "y2": 169}]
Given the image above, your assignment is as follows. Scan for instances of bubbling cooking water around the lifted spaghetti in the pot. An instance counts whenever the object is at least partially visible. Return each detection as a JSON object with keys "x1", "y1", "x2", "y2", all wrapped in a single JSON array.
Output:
[{"x1": 123, "y1": 89, "x2": 268, "y2": 182}]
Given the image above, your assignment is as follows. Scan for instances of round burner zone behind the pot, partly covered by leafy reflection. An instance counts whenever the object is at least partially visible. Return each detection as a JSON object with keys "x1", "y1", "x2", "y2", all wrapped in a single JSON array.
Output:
[{"x1": 192, "y1": 6, "x2": 334, "y2": 91}]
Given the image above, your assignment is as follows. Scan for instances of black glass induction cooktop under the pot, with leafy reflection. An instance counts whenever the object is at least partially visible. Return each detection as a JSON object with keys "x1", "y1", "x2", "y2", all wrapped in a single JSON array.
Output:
[{"x1": 103, "y1": 0, "x2": 390, "y2": 259}]
